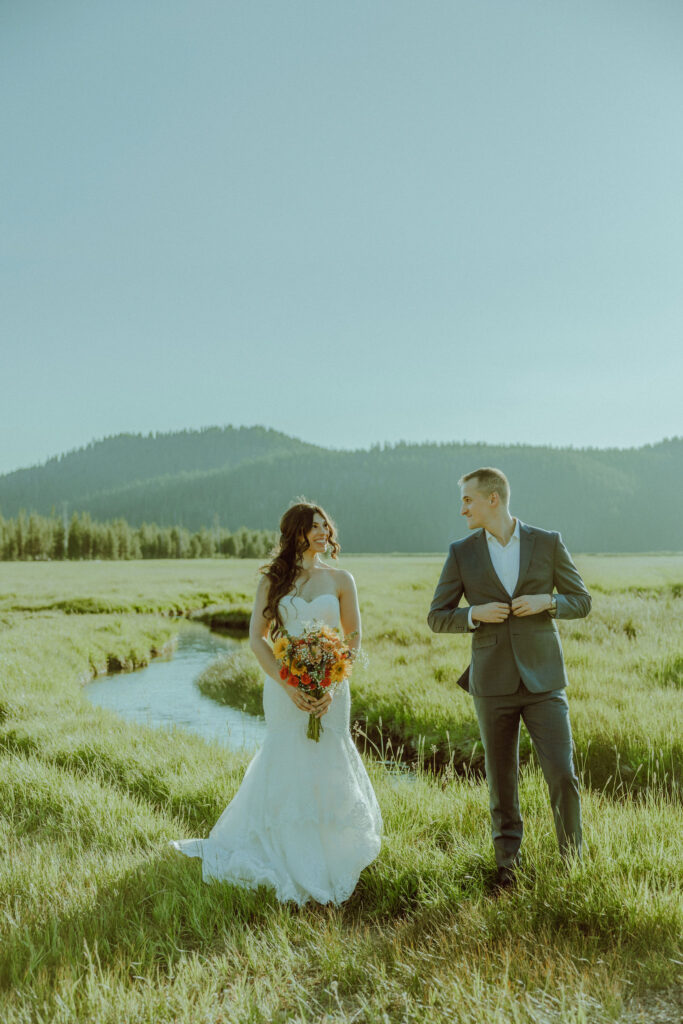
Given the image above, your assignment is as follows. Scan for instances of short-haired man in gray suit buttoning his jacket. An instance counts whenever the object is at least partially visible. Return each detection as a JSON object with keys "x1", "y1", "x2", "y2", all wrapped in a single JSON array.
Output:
[{"x1": 427, "y1": 468, "x2": 591, "y2": 888}]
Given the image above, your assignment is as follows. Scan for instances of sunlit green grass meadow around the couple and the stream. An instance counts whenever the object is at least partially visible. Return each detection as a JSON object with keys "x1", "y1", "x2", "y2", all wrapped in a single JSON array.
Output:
[{"x1": 0, "y1": 556, "x2": 683, "y2": 1024}]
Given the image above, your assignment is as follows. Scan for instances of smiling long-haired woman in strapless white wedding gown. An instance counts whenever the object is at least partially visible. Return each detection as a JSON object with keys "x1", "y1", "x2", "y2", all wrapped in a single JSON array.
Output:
[{"x1": 171, "y1": 502, "x2": 382, "y2": 905}]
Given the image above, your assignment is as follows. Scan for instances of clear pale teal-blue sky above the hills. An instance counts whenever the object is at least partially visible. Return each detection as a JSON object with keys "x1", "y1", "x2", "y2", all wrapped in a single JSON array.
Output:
[{"x1": 0, "y1": 0, "x2": 683, "y2": 472}]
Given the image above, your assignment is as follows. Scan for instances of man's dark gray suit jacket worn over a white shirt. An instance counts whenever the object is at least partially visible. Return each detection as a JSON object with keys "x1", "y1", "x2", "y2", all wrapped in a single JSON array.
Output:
[{"x1": 427, "y1": 523, "x2": 591, "y2": 696}]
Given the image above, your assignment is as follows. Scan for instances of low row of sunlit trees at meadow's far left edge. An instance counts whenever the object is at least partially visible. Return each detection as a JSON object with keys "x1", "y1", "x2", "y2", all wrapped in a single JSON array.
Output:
[{"x1": 0, "y1": 510, "x2": 276, "y2": 561}]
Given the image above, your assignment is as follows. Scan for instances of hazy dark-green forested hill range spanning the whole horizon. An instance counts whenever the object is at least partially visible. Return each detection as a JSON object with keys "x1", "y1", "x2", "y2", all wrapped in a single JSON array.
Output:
[{"x1": 0, "y1": 429, "x2": 683, "y2": 552}]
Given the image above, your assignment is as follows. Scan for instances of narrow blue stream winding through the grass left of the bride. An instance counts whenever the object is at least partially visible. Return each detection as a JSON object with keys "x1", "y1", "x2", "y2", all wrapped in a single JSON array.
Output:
[{"x1": 83, "y1": 623, "x2": 265, "y2": 751}]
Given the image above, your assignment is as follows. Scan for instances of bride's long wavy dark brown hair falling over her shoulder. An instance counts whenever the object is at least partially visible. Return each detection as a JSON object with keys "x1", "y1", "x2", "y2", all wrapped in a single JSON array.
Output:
[{"x1": 260, "y1": 501, "x2": 341, "y2": 638}]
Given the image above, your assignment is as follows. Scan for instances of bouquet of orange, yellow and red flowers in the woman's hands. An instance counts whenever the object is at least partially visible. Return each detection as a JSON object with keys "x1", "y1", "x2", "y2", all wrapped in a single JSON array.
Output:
[{"x1": 272, "y1": 623, "x2": 351, "y2": 742}]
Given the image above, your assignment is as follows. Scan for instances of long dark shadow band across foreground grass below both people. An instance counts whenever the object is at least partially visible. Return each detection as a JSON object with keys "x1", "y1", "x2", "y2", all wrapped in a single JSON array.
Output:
[{"x1": 0, "y1": 849, "x2": 672, "y2": 995}]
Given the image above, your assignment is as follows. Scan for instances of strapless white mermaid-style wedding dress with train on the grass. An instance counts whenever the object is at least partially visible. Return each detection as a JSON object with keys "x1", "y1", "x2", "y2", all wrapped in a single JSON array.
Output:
[{"x1": 171, "y1": 594, "x2": 382, "y2": 905}]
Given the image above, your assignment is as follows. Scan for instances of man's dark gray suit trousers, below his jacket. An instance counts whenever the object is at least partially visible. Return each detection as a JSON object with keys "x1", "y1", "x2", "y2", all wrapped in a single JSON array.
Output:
[{"x1": 474, "y1": 681, "x2": 582, "y2": 867}]
